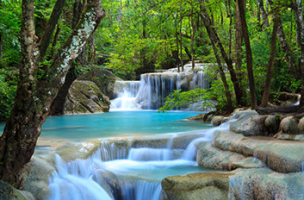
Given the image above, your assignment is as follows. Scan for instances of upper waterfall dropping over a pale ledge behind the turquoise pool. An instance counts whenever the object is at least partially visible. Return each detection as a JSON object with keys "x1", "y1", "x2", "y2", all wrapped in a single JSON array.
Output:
[{"x1": 111, "y1": 65, "x2": 210, "y2": 110}]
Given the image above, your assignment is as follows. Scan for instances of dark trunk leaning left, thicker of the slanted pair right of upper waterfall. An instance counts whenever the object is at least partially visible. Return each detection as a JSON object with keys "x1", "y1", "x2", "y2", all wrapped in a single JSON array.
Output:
[{"x1": 200, "y1": 2, "x2": 243, "y2": 105}]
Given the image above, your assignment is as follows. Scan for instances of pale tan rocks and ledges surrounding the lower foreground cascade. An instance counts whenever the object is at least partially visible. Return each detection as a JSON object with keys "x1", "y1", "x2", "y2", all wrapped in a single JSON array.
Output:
[{"x1": 0, "y1": 111, "x2": 304, "y2": 200}]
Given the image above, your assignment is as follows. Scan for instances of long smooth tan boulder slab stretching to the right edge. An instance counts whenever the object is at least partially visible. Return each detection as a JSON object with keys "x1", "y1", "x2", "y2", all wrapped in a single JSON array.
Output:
[{"x1": 214, "y1": 131, "x2": 304, "y2": 173}]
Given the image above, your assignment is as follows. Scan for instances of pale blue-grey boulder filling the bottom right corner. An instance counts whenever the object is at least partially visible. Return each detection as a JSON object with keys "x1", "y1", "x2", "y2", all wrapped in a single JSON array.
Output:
[{"x1": 227, "y1": 168, "x2": 304, "y2": 200}]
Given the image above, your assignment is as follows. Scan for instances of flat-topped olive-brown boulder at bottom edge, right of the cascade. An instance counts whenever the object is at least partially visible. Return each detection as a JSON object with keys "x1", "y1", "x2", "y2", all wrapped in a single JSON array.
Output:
[{"x1": 161, "y1": 173, "x2": 232, "y2": 200}]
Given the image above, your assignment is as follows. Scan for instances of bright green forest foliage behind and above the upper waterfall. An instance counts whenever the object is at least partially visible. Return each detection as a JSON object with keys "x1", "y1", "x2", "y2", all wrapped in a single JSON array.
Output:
[{"x1": 0, "y1": 0, "x2": 303, "y2": 121}]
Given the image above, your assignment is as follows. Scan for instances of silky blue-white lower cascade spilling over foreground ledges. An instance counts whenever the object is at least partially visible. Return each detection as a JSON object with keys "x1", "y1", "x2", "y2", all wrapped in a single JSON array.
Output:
[{"x1": 48, "y1": 119, "x2": 234, "y2": 200}]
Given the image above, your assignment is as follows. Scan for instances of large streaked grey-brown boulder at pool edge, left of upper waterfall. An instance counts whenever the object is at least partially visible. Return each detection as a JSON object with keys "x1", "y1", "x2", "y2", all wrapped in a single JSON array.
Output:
[{"x1": 64, "y1": 80, "x2": 111, "y2": 114}]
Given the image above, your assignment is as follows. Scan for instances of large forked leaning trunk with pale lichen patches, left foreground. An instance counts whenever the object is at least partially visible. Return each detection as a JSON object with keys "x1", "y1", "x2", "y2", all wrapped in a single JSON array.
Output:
[{"x1": 0, "y1": 0, "x2": 105, "y2": 185}]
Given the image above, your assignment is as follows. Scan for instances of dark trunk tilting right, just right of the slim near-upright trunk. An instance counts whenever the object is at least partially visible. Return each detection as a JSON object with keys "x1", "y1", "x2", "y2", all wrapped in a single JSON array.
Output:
[{"x1": 261, "y1": 12, "x2": 280, "y2": 107}]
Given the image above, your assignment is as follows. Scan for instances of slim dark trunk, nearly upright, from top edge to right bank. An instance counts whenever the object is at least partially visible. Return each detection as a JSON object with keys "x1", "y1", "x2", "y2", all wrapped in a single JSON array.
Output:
[{"x1": 238, "y1": 1, "x2": 257, "y2": 109}]
